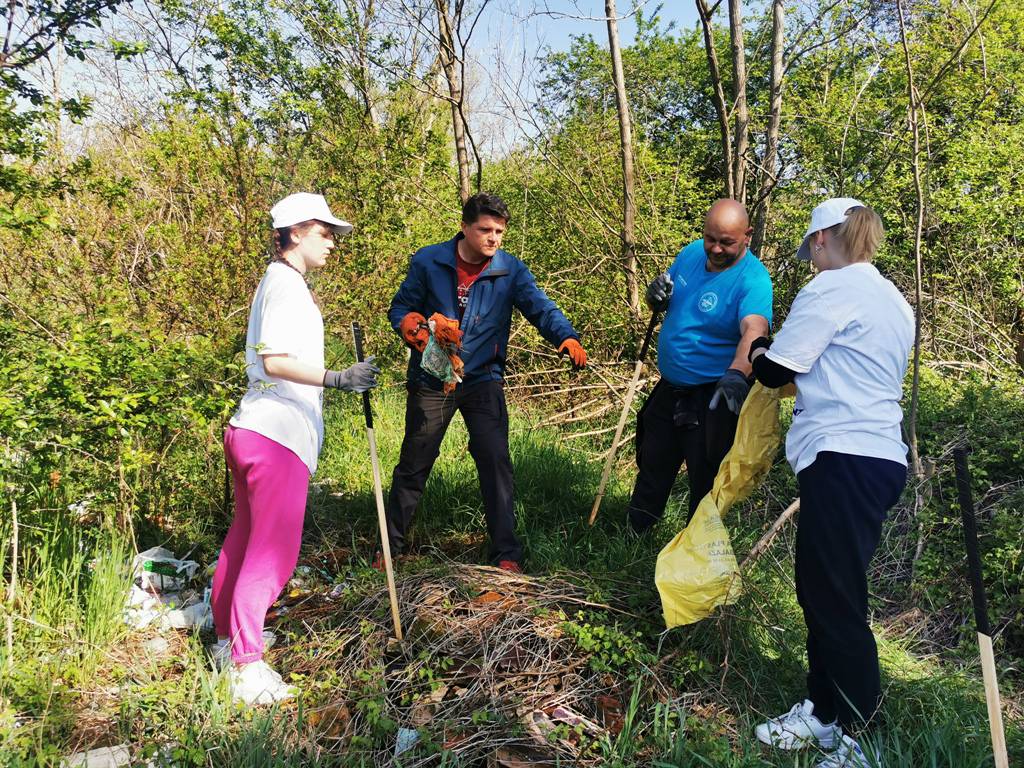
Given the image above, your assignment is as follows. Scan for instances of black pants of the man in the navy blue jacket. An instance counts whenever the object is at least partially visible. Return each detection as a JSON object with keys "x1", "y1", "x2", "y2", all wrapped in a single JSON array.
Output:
[{"x1": 387, "y1": 381, "x2": 522, "y2": 563}]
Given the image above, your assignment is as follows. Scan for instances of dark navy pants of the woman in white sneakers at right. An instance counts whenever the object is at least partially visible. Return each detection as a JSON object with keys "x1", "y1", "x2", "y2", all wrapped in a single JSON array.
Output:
[{"x1": 797, "y1": 452, "x2": 906, "y2": 731}]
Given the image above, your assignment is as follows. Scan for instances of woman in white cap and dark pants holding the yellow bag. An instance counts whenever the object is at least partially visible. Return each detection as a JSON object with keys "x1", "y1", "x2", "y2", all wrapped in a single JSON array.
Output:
[{"x1": 751, "y1": 198, "x2": 914, "y2": 768}]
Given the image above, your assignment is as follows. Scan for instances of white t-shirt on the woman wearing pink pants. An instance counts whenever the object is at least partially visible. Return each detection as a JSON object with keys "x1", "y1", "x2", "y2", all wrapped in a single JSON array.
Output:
[{"x1": 230, "y1": 262, "x2": 324, "y2": 475}]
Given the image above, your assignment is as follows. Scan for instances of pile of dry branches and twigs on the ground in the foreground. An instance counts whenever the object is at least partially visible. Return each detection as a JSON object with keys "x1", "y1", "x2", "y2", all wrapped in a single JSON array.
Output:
[{"x1": 278, "y1": 564, "x2": 671, "y2": 768}]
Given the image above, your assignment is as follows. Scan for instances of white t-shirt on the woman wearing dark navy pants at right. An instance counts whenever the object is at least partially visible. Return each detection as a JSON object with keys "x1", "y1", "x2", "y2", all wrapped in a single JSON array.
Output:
[{"x1": 766, "y1": 263, "x2": 913, "y2": 479}]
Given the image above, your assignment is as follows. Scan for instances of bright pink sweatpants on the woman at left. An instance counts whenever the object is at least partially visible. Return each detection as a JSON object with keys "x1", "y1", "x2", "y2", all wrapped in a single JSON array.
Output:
[{"x1": 212, "y1": 425, "x2": 309, "y2": 664}]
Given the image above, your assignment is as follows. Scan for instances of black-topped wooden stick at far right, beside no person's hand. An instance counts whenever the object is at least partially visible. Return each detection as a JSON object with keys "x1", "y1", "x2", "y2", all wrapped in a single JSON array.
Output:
[{"x1": 953, "y1": 447, "x2": 1010, "y2": 768}]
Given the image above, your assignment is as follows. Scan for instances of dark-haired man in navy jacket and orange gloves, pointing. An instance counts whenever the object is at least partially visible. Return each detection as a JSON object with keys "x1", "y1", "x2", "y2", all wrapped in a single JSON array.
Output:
[{"x1": 387, "y1": 193, "x2": 587, "y2": 572}]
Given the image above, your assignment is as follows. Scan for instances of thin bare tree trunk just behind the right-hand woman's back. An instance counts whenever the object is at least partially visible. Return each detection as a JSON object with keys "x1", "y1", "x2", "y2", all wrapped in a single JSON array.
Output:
[{"x1": 896, "y1": 0, "x2": 925, "y2": 477}]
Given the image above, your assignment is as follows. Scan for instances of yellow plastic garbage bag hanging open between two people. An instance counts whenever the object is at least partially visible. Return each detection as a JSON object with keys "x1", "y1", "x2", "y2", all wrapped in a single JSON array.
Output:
[{"x1": 654, "y1": 383, "x2": 782, "y2": 629}]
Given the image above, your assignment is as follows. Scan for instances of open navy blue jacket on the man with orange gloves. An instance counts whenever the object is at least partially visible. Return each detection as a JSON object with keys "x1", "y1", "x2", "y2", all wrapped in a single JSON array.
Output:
[{"x1": 387, "y1": 233, "x2": 580, "y2": 389}]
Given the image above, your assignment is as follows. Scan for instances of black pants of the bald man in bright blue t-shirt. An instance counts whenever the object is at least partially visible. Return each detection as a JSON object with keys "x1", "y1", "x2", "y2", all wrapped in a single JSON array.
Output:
[{"x1": 629, "y1": 379, "x2": 738, "y2": 532}]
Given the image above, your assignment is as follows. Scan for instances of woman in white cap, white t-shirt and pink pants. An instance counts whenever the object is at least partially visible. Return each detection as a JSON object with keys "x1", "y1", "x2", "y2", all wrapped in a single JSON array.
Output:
[{"x1": 213, "y1": 193, "x2": 380, "y2": 705}]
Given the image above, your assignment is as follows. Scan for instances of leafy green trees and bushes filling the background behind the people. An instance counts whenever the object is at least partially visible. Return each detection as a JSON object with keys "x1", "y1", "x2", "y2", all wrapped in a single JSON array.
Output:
[{"x1": 0, "y1": 0, "x2": 1024, "y2": 708}]
